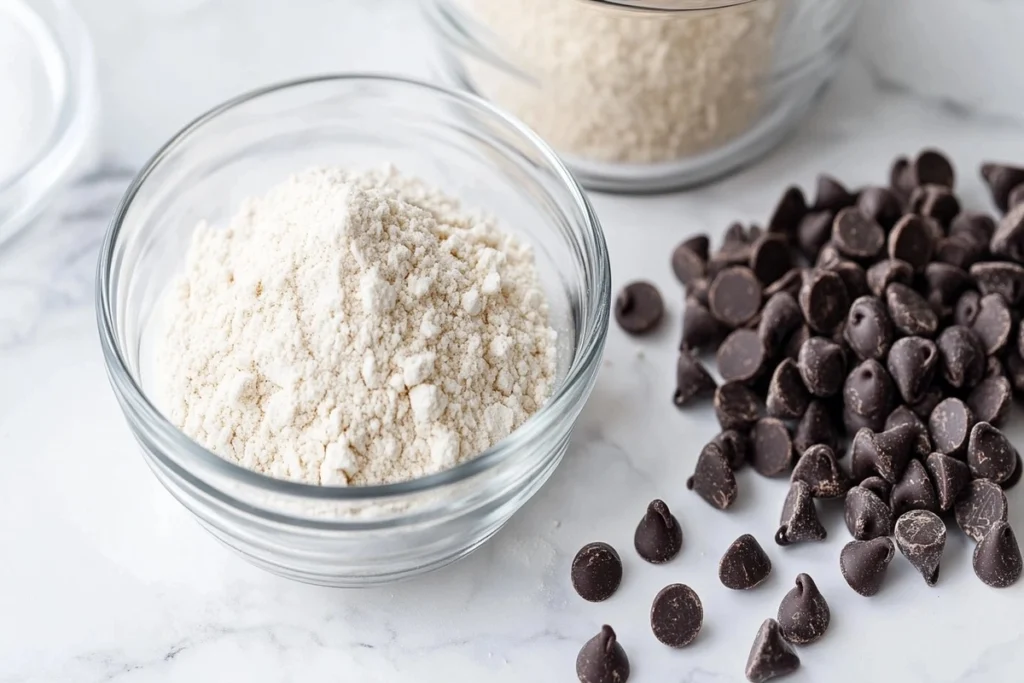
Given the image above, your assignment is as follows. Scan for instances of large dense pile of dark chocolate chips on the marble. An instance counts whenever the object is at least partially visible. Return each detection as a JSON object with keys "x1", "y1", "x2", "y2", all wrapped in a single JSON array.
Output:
[{"x1": 602, "y1": 150, "x2": 1024, "y2": 680}]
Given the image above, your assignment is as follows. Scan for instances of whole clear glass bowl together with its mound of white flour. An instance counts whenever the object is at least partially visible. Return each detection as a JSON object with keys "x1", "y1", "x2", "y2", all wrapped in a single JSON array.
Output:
[{"x1": 97, "y1": 75, "x2": 610, "y2": 586}]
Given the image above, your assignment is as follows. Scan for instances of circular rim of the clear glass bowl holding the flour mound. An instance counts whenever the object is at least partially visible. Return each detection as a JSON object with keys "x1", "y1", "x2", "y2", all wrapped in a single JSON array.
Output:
[{"x1": 96, "y1": 73, "x2": 611, "y2": 502}]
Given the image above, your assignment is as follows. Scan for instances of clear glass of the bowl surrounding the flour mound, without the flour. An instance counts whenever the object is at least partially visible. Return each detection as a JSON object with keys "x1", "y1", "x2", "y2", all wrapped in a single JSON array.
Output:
[{"x1": 97, "y1": 75, "x2": 610, "y2": 586}]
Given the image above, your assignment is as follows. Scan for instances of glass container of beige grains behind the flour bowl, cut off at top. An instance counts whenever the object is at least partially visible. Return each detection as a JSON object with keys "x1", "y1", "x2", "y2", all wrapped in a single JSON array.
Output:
[{"x1": 424, "y1": 0, "x2": 861, "y2": 193}]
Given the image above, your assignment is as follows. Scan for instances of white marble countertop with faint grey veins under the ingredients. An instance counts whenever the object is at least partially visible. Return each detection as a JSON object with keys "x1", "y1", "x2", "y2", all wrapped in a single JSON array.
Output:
[{"x1": 6, "y1": 0, "x2": 1024, "y2": 683}]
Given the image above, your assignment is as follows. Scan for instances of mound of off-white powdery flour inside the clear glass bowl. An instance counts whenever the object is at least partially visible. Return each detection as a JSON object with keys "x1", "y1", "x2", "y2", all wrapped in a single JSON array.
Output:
[{"x1": 159, "y1": 169, "x2": 555, "y2": 485}]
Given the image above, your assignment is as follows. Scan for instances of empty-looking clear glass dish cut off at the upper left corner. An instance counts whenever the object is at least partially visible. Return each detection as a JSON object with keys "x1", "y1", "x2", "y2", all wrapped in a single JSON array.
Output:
[{"x1": 0, "y1": 0, "x2": 97, "y2": 245}]
